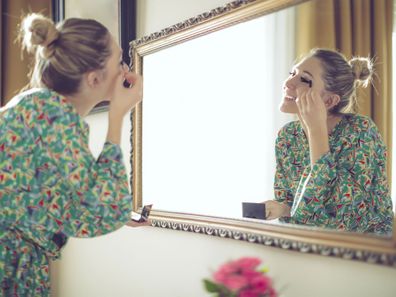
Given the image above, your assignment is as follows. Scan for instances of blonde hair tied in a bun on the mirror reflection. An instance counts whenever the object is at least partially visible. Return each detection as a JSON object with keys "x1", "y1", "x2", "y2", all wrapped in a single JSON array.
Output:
[{"x1": 308, "y1": 48, "x2": 374, "y2": 114}]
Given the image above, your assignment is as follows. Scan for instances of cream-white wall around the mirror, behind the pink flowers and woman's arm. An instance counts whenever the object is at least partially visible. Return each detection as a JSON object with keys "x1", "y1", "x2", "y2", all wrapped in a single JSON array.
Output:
[{"x1": 52, "y1": 0, "x2": 396, "y2": 297}]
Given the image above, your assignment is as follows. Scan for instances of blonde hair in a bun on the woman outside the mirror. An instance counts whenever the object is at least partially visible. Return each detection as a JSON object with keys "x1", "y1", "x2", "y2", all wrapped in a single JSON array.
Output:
[{"x1": 20, "y1": 13, "x2": 111, "y2": 95}]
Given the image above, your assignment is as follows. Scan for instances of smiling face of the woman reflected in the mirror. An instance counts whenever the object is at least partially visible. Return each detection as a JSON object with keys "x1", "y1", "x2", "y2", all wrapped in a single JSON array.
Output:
[{"x1": 279, "y1": 57, "x2": 325, "y2": 114}]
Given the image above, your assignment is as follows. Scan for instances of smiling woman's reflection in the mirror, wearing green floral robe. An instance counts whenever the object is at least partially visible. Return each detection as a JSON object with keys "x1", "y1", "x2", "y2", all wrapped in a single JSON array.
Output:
[{"x1": 265, "y1": 49, "x2": 393, "y2": 235}]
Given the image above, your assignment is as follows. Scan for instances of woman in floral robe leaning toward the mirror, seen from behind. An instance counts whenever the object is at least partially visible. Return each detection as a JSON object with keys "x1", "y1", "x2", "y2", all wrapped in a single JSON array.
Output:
[{"x1": 0, "y1": 14, "x2": 145, "y2": 296}]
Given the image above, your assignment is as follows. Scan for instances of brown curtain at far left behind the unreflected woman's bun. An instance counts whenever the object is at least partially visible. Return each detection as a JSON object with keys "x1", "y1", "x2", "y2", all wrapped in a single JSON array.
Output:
[{"x1": 0, "y1": 0, "x2": 51, "y2": 105}]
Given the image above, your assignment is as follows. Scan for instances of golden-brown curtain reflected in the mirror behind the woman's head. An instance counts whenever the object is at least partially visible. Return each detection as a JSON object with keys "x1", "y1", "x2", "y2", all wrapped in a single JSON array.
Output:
[{"x1": 295, "y1": 0, "x2": 393, "y2": 182}]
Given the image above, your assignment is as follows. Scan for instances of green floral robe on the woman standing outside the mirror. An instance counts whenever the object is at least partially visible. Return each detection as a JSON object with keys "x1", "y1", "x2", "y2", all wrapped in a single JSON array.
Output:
[{"x1": 0, "y1": 89, "x2": 132, "y2": 296}]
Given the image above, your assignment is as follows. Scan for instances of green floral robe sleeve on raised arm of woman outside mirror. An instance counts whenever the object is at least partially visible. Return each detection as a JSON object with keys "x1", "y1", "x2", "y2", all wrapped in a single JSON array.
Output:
[{"x1": 30, "y1": 93, "x2": 132, "y2": 237}]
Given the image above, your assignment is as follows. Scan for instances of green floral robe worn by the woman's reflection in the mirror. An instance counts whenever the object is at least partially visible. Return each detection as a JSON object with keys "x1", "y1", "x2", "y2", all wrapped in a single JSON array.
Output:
[{"x1": 274, "y1": 115, "x2": 393, "y2": 235}]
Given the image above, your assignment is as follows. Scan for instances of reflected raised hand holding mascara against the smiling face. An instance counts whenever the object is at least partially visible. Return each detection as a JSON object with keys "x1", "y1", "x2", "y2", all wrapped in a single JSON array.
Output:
[{"x1": 296, "y1": 88, "x2": 327, "y2": 132}]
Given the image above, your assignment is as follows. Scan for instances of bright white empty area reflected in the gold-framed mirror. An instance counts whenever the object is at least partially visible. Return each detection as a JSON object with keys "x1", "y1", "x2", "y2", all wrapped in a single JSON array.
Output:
[{"x1": 142, "y1": 9, "x2": 294, "y2": 218}]
